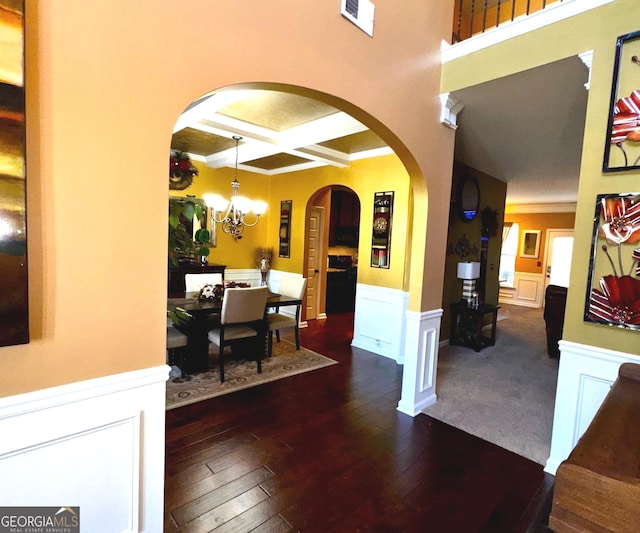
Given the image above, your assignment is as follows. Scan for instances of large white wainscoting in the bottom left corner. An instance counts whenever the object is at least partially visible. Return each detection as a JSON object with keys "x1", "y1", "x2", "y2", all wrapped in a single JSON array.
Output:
[{"x1": 0, "y1": 365, "x2": 169, "y2": 533}]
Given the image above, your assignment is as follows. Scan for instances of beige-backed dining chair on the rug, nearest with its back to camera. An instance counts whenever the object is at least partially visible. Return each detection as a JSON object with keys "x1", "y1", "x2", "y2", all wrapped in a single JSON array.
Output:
[{"x1": 208, "y1": 287, "x2": 269, "y2": 383}]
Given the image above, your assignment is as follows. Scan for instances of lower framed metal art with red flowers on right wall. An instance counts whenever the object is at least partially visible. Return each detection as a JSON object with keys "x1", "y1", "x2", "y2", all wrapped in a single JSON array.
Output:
[{"x1": 584, "y1": 193, "x2": 640, "y2": 330}]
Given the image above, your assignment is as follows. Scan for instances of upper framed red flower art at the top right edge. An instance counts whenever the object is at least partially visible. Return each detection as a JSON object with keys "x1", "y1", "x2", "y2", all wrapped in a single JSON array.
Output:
[{"x1": 602, "y1": 31, "x2": 640, "y2": 172}]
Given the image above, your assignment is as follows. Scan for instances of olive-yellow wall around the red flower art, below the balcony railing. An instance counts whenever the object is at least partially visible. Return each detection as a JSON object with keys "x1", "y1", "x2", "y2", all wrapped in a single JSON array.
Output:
[{"x1": 441, "y1": 0, "x2": 640, "y2": 355}]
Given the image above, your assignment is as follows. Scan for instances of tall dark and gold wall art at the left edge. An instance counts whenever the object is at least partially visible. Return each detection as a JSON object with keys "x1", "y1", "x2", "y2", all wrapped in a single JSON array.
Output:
[{"x1": 0, "y1": 0, "x2": 29, "y2": 346}]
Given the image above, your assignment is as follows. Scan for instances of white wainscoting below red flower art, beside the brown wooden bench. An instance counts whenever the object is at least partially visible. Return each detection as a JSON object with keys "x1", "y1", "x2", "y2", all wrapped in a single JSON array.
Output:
[{"x1": 545, "y1": 341, "x2": 640, "y2": 475}]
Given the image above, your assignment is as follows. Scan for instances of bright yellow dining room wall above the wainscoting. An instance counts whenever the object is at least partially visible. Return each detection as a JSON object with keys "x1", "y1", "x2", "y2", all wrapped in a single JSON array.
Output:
[{"x1": 169, "y1": 155, "x2": 409, "y2": 289}]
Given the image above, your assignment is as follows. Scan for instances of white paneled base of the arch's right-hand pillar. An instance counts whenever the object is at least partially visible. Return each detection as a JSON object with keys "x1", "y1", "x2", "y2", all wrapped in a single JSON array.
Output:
[{"x1": 397, "y1": 309, "x2": 442, "y2": 416}]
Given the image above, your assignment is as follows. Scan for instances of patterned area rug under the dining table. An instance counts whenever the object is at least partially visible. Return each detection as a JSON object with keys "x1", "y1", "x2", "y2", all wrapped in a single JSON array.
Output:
[{"x1": 166, "y1": 339, "x2": 337, "y2": 411}]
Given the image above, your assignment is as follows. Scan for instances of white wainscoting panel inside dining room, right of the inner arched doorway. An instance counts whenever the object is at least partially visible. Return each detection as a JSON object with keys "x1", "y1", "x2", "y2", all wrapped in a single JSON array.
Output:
[{"x1": 351, "y1": 283, "x2": 409, "y2": 364}]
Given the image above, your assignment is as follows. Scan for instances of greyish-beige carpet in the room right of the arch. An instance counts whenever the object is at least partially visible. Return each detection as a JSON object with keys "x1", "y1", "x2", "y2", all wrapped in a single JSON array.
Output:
[{"x1": 424, "y1": 305, "x2": 558, "y2": 464}]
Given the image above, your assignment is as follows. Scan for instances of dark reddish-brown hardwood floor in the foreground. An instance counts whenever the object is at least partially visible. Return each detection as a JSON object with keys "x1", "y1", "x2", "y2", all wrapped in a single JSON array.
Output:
[{"x1": 165, "y1": 314, "x2": 553, "y2": 533}]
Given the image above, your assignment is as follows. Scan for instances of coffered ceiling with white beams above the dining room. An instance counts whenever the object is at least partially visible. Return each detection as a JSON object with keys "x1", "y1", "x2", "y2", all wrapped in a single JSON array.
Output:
[{"x1": 171, "y1": 90, "x2": 392, "y2": 175}]
